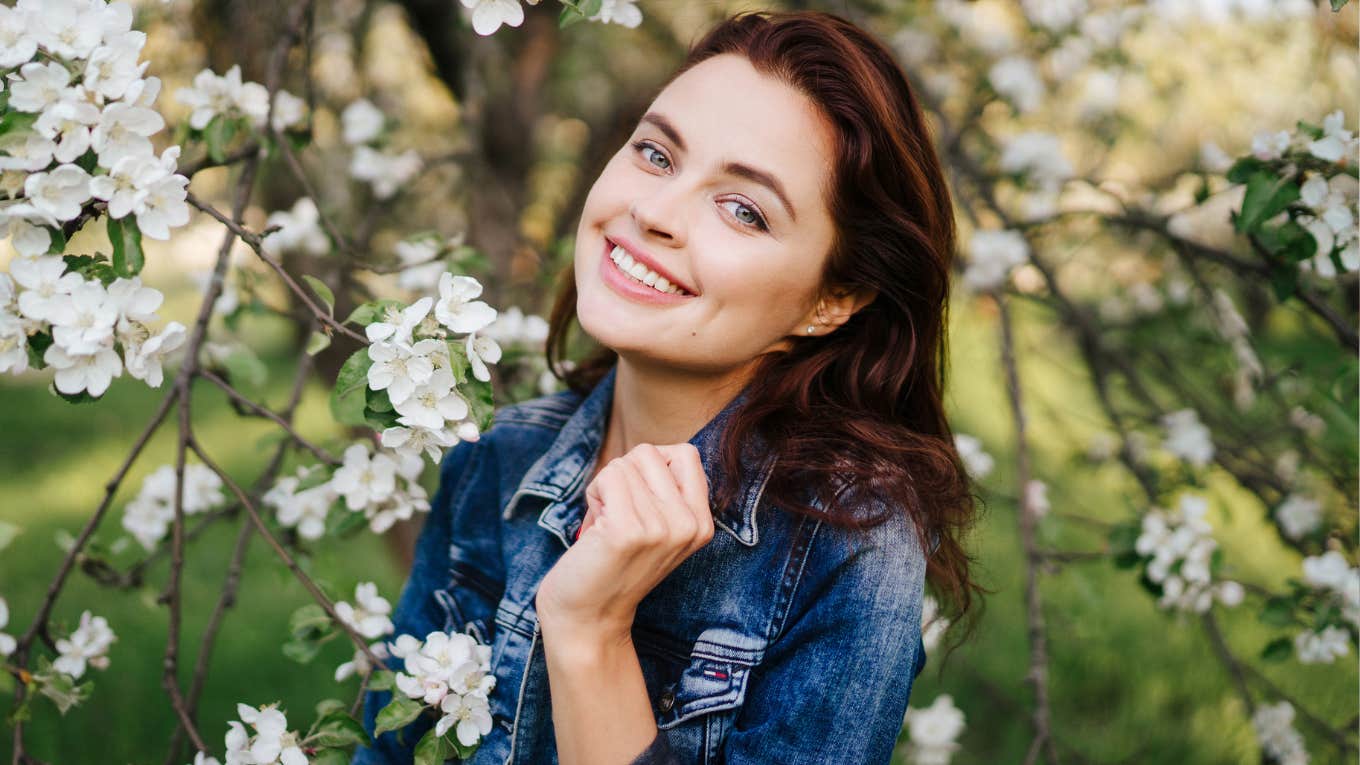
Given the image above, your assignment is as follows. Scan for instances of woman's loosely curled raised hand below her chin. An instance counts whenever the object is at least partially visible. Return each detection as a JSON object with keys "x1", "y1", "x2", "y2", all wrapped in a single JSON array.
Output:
[{"x1": 534, "y1": 444, "x2": 713, "y2": 640}]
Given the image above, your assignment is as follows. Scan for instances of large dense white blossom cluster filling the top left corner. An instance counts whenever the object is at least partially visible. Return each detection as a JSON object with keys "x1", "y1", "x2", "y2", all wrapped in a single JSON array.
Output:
[{"x1": 0, "y1": 0, "x2": 189, "y2": 238}]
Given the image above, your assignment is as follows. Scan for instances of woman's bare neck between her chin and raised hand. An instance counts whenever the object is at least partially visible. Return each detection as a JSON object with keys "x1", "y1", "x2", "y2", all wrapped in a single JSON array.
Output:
[{"x1": 598, "y1": 357, "x2": 751, "y2": 467}]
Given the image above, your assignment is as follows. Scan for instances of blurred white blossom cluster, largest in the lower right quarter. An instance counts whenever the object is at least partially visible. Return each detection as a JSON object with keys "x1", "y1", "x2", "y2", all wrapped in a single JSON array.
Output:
[{"x1": 1134, "y1": 494, "x2": 1243, "y2": 614}]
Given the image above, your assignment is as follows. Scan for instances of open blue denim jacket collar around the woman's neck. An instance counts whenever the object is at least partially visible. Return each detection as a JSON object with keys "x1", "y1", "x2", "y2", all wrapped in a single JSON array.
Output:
[{"x1": 503, "y1": 365, "x2": 774, "y2": 547}]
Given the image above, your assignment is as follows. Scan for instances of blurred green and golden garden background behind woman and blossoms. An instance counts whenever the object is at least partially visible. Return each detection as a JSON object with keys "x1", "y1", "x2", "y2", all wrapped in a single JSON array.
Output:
[{"x1": 0, "y1": 0, "x2": 1360, "y2": 765}]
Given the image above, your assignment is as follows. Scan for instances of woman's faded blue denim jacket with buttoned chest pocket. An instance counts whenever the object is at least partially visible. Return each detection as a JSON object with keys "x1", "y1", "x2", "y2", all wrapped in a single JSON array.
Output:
[{"x1": 354, "y1": 370, "x2": 926, "y2": 765}]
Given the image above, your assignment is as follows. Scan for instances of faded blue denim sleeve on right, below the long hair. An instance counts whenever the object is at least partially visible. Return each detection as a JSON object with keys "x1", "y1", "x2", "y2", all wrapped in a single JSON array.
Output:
[{"x1": 721, "y1": 519, "x2": 926, "y2": 765}]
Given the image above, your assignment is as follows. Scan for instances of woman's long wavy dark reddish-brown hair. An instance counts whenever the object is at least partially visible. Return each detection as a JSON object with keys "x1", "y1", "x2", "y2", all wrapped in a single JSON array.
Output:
[{"x1": 548, "y1": 11, "x2": 986, "y2": 652}]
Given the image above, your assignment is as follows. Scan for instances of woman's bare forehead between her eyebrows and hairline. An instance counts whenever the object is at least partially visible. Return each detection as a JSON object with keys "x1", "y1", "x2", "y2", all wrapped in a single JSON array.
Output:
[{"x1": 651, "y1": 53, "x2": 832, "y2": 208}]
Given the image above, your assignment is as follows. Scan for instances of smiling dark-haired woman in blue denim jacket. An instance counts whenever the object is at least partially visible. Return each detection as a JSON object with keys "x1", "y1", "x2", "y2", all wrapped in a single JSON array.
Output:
[{"x1": 356, "y1": 12, "x2": 976, "y2": 765}]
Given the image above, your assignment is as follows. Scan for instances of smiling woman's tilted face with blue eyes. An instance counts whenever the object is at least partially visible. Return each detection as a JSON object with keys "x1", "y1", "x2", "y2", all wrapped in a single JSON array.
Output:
[{"x1": 575, "y1": 54, "x2": 834, "y2": 374}]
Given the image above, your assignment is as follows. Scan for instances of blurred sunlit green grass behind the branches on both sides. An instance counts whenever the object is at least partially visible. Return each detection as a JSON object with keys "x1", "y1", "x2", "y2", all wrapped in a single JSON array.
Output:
[{"x1": 0, "y1": 295, "x2": 1357, "y2": 765}]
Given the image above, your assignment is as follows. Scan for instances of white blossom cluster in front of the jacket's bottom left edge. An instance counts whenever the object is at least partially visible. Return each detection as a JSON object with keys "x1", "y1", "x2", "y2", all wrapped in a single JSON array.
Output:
[{"x1": 390, "y1": 632, "x2": 496, "y2": 746}]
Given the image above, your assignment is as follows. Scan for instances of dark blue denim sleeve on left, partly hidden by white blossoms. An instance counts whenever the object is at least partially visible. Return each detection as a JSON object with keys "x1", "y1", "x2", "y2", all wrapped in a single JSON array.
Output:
[{"x1": 351, "y1": 441, "x2": 476, "y2": 765}]
